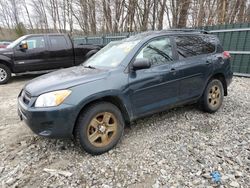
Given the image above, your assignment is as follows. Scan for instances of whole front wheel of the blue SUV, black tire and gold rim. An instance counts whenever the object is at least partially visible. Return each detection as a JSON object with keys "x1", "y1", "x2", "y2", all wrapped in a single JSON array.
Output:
[{"x1": 74, "y1": 102, "x2": 125, "y2": 155}]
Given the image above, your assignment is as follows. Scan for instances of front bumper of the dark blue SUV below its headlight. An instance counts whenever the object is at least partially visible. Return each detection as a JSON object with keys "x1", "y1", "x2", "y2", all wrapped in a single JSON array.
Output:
[{"x1": 18, "y1": 97, "x2": 77, "y2": 138}]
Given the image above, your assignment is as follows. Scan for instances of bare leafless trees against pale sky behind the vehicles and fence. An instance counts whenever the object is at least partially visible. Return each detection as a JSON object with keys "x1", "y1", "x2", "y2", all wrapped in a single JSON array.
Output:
[{"x1": 0, "y1": 0, "x2": 250, "y2": 40}]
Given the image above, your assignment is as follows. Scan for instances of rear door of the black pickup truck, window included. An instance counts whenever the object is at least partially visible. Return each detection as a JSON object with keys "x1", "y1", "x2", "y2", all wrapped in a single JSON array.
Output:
[{"x1": 47, "y1": 35, "x2": 74, "y2": 68}]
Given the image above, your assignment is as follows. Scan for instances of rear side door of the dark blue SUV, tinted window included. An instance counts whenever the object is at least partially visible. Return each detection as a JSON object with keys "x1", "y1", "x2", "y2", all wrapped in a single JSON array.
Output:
[{"x1": 175, "y1": 35, "x2": 215, "y2": 101}]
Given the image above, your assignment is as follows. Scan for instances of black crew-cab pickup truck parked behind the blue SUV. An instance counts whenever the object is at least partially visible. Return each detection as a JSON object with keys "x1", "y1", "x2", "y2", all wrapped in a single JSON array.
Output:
[{"x1": 0, "y1": 34, "x2": 101, "y2": 84}]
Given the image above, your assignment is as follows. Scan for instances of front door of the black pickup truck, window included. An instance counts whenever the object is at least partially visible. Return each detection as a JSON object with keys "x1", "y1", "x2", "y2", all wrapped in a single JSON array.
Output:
[{"x1": 14, "y1": 35, "x2": 49, "y2": 72}]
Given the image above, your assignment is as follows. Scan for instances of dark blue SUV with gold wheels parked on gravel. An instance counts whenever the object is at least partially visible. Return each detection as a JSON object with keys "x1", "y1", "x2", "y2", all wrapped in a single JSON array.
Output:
[{"x1": 18, "y1": 31, "x2": 232, "y2": 154}]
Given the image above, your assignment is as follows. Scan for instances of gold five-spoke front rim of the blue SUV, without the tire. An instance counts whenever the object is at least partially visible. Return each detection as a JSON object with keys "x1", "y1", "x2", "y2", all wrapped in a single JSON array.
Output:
[{"x1": 87, "y1": 112, "x2": 118, "y2": 147}]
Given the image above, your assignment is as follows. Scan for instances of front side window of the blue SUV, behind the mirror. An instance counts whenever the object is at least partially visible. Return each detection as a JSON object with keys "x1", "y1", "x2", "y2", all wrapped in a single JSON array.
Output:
[{"x1": 136, "y1": 37, "x2": 173, "y2": 66}]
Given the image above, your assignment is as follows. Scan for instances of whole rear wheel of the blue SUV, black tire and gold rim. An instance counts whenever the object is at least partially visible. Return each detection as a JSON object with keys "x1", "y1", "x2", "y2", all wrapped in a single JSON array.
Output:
[{"x1": 201, "y1": 79, "x2": 224, "y2": 113}]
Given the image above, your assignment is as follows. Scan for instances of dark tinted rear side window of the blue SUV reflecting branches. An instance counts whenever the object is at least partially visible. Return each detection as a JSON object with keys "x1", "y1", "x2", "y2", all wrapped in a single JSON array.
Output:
[{"x1": 175, "y1": 36, "x2": 215, "y2": 59}]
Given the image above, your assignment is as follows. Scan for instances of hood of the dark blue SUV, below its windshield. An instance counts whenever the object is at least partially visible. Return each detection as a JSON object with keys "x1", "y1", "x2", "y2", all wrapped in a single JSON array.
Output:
[{"x1": 24, "y1": 66, "x2": 109, "y2": 97}]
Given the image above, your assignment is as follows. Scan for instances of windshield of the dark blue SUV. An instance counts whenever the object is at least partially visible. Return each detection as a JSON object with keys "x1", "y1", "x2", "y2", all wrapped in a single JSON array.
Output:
[{"x1": 83, "y1": 40, "x2": 140, "y2": 67}]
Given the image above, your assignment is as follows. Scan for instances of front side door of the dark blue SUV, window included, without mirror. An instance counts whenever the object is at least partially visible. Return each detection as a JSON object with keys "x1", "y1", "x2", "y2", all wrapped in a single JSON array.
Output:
[{"x1": 129, "y1": 37, "x2": 181, "y2": 118}]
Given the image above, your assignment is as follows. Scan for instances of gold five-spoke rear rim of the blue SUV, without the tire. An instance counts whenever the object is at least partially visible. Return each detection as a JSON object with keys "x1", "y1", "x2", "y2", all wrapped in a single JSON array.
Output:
[{"x1": 208, "y1": 85, "x2": 221, "y2": 108}]
